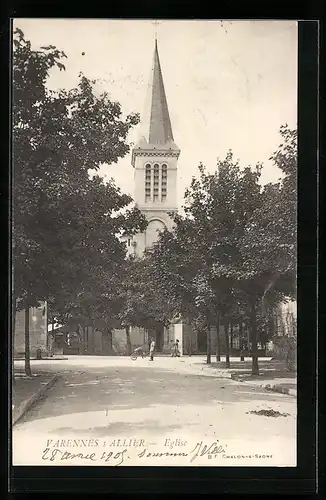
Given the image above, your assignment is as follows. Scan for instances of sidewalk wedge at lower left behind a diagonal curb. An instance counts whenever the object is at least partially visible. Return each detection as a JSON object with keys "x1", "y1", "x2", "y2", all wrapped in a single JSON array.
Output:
[{"x1": 12, "y1": 371, "x2": 58, "y2": 425}]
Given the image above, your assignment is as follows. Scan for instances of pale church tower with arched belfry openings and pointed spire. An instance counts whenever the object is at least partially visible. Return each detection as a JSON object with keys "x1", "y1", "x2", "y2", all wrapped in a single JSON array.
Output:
[{"x1": 128, "y1": 40, "x2": 180, "y2": 256}]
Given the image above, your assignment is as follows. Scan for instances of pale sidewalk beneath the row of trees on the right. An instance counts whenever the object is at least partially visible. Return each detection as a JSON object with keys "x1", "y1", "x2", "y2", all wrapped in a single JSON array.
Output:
[{"x1": 180, "y1": 356, "x2": 297, "y2": 396}]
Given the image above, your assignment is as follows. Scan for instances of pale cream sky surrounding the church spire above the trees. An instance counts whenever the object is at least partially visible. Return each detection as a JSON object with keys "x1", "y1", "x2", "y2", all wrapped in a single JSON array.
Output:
[{"x1": 14, "y1": 19, "x2": 297, "y2": 207}]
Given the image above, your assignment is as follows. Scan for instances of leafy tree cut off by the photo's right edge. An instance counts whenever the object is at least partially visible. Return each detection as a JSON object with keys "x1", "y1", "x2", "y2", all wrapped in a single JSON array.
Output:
[{"x1": 240, "y1": 126, "x2": 297, "y2": 374}]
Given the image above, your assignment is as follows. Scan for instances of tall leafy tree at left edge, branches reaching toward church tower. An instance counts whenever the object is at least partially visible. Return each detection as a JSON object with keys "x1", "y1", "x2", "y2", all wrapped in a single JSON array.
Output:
[{"x1": 13, "y1": 30, "x2": 146, "y2": 372}]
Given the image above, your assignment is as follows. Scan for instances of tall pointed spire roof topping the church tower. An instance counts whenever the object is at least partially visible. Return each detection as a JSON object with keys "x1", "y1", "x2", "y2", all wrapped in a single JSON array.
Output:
[{"x1": 135, "y1": 40, "x2": 179, "y2": 150}]
